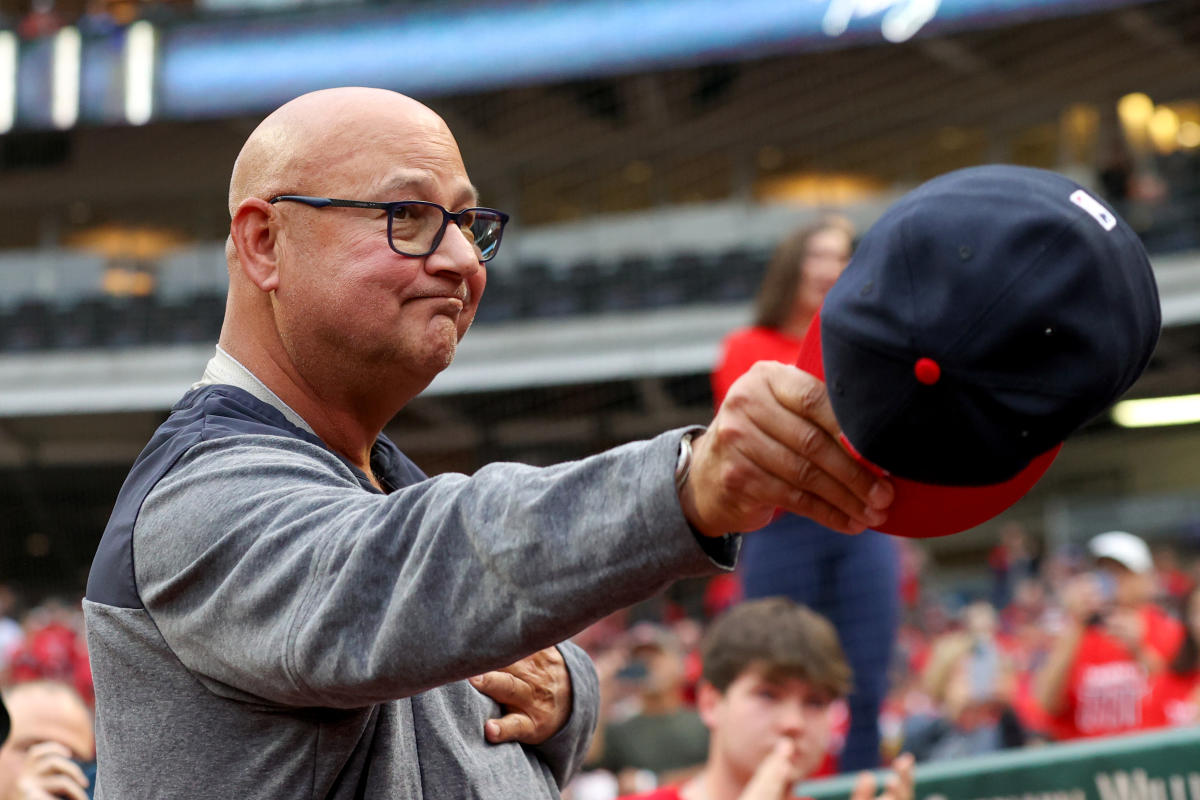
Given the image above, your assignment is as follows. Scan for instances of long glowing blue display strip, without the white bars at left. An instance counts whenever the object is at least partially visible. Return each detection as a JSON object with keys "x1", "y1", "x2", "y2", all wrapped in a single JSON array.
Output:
[{"x1": 160, "y1": 0, "x2": 1144, "y2": 118}]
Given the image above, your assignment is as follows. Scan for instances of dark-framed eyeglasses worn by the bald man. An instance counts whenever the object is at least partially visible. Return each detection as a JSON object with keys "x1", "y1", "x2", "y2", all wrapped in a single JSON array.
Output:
[{"x1": 268, "y1": 194, "x2": 509, "y2": 263}]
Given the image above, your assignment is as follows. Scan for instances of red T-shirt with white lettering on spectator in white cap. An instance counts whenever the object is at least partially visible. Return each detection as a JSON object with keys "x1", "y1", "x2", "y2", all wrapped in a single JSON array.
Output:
[{"x1": 1049, "y1": 606, "x2": 1183, "y2": 740}]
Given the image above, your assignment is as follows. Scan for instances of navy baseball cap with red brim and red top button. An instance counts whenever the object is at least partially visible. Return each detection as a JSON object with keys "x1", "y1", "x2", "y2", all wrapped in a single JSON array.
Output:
[{"x1": 799, "y1": 166, "x2": 1162, "y2": 537}]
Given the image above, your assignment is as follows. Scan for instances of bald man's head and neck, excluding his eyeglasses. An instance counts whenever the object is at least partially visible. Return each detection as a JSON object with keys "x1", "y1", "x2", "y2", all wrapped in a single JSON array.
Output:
[{"x1": 220, "y1": 88, "x2": 486, "y2": 450}]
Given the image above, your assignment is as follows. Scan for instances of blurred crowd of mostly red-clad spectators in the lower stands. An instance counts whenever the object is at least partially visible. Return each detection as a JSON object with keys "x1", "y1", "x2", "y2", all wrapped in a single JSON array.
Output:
[{"x1": 0, "y1": 524, "x2": 1200, "y2": 800}]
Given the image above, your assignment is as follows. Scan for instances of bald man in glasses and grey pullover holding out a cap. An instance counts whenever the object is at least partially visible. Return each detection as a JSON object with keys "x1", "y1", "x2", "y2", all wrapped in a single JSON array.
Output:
[{"x1": 84, "y1": 89, "x2": 892, "y2": 800}]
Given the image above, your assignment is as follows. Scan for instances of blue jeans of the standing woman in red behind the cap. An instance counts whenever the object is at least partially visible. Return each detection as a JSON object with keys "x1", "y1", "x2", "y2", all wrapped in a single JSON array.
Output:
[{"x1": 740, "y1": 515, "x2": 900, "y2": 772}]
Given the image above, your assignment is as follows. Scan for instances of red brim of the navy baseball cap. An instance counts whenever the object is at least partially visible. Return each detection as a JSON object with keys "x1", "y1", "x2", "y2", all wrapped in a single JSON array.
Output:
[{"x1": 797, "y1": 314, "x2": 1062, "y2": 539}]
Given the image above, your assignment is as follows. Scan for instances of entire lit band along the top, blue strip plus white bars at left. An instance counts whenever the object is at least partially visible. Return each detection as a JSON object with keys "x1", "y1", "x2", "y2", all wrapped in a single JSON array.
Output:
[{"x1": 0, "y1": 0, "x2": 1151, "y2": 130}]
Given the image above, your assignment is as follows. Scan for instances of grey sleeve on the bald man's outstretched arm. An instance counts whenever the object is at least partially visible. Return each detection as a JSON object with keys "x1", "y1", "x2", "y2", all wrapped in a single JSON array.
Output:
[{"x1": 133, "y1": 431, "x2": 740, "y2": 708}]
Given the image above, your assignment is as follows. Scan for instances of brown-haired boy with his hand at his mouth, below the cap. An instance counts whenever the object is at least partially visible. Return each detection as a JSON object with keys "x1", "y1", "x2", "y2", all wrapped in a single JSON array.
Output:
[{"x1": 624, "y1": 597, "x2": 912, "y2": 800}]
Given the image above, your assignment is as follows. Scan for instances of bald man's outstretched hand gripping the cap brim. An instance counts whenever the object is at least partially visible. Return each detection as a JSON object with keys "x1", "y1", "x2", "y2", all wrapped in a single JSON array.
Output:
[{"x1": 679, "y1": 361, "x2": 894, "y2": 536}]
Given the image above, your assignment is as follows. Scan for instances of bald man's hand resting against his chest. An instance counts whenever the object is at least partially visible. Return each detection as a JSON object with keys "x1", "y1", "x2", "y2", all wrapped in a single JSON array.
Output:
[{"x1": 470, "y1": 648, "x2": 571, "y2": 745}]
